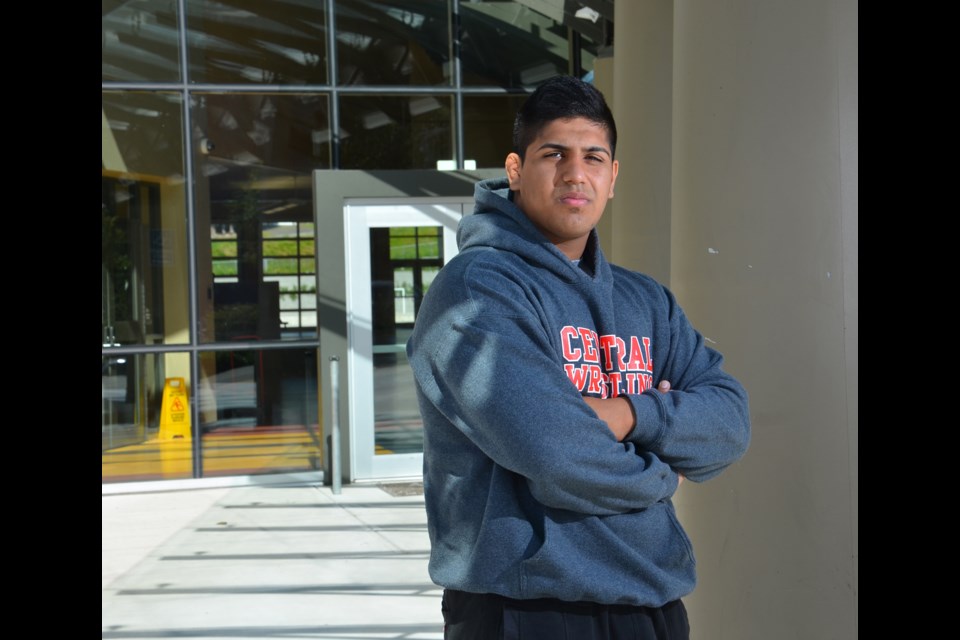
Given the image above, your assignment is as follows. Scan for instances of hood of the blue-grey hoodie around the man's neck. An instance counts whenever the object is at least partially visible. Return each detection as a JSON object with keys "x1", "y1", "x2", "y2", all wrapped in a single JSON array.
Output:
[{"x1": 457, "y1": 178, "x2": 605, "y2": 280}]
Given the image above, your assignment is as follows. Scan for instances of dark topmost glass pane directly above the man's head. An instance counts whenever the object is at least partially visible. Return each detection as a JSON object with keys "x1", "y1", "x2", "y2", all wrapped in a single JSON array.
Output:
[{"x1": 460, "y1": 1, "x2": 596, "y2": 89}]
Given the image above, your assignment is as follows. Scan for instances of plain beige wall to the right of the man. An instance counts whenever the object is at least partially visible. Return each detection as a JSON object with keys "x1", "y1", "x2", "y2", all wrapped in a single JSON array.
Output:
[{"x1": 612, "y1": 0, "x2": 859, "y2": 640}]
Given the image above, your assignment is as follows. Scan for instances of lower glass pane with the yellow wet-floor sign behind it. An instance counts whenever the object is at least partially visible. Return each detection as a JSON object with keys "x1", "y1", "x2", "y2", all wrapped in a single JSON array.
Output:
[{"x1": 100, "y1": 353, "x2": 193, "y2": 483}]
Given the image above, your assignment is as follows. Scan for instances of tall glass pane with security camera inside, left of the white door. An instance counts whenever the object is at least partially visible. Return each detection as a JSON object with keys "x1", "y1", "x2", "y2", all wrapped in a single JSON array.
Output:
[{"x1": 193, "y1": 93, "x2": 330, "y2": 342}]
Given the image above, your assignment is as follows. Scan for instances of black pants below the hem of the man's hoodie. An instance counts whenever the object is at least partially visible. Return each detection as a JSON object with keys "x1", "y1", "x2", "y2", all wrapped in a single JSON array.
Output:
[{"x1": 441, "y1": 589, "x2": 690, "y2": 640}]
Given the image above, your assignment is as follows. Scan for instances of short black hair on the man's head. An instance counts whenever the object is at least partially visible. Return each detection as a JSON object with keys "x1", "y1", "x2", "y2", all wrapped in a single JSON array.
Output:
[{"x1": 513, "y1": 76, "x2": 617, "y2": 161}]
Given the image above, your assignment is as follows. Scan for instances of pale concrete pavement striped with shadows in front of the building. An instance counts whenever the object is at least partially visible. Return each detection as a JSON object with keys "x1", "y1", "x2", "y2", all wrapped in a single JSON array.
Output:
[{"x1": 101, "y1": 483, "x2": 443, "y2": 640}]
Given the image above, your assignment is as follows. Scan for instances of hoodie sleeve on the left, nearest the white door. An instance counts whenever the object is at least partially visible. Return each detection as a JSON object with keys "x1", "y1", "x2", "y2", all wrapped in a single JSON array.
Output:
[{"x1": 408, "y1": 255, "x2": 678, "y2": 515}]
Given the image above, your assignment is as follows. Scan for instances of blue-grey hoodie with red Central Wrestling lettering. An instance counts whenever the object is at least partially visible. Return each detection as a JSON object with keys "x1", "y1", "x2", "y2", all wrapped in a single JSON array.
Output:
[{"x1": 407, "y1": 179, "x2": 750, "y2": 606}]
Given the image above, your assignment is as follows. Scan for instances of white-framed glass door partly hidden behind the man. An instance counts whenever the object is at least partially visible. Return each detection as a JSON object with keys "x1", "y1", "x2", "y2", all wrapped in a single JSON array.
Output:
[{"x1": 345, "y1": 199, "x2": 472, "y2": 480}]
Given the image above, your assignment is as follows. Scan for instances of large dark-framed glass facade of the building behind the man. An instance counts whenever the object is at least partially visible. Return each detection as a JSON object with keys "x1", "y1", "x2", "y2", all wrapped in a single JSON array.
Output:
[{"x1": 101, "y1": 0, "x2": 612, "y2": 483}]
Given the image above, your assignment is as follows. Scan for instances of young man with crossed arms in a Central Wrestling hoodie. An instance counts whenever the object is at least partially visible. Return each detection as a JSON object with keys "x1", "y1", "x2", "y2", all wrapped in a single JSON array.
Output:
[{"x1": 407, "y1": 72, "x2": 750, "y2": 640}]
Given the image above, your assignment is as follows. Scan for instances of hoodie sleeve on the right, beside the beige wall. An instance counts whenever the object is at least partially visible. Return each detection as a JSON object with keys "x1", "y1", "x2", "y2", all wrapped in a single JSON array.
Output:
[{"x1": 627, "y1": 289, "x2": 750, "y2": 482}]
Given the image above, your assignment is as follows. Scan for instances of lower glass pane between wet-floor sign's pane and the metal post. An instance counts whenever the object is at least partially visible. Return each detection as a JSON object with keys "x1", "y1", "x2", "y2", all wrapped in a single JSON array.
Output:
[{"x1": 199, "y1": 349, "x2": 323, "y2": 477}]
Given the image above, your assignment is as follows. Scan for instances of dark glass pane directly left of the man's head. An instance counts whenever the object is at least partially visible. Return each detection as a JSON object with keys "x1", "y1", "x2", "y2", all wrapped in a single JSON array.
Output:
[{"x1": 463, "y1": 96, "x2": 526, "y2": 168}]
